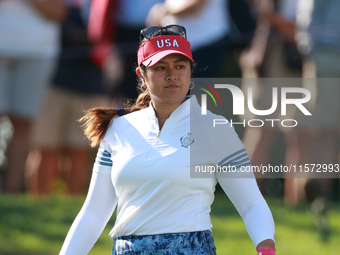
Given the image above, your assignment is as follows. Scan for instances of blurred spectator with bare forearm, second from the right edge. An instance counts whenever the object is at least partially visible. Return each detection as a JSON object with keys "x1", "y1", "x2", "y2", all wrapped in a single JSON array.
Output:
[{"x1": 240, "y1": 0, "x2": 302, "y2": 191}]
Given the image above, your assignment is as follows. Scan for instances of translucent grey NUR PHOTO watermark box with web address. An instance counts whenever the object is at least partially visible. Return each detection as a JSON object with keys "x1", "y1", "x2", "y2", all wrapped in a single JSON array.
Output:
[{"x1": 190, "y1": 78, "x2": 340, "y2": 178}]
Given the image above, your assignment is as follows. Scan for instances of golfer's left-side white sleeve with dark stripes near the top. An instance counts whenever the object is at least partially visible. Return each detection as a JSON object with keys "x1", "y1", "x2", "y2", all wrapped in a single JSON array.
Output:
[{"x1": 59, "y1": 144, "x2": 117, "y2": 255}]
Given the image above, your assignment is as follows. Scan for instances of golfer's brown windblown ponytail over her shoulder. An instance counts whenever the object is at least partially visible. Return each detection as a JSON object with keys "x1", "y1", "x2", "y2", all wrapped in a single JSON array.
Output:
[{"x1": 78, "y1": 91, "x2": 151, "y2": 147}]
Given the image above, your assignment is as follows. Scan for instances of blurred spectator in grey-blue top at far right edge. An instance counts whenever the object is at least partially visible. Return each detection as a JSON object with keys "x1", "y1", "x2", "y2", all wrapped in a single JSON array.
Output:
[{"x1": 285, "y1": 0, "x2": 340, "y2": 204}]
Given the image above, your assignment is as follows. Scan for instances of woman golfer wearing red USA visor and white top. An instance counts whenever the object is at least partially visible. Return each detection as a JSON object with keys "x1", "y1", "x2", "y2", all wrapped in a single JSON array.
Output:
[{"x1": 60, "y1": 25, "x2": 275, "y2": 255}]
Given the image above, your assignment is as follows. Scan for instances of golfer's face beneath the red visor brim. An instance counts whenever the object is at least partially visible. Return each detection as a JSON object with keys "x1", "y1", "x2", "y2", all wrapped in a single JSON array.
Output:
[{"x1": 143, "y1": 54, "x2": 191, "y2": 106}]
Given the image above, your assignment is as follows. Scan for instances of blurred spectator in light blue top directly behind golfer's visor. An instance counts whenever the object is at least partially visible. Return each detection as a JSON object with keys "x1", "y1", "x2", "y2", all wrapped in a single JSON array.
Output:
[{"x1": 146, "y1": 0, "x2": 231, "y2": 78}]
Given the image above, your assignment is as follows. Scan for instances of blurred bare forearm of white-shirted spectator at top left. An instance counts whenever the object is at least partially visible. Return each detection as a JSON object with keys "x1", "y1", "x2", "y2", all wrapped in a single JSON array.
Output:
[{"x1": 28, "y1": 0, "x2": 66, "y2": 22}]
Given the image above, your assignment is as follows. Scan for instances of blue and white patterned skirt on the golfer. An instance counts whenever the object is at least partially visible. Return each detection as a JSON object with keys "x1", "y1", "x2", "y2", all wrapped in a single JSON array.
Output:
[{"x1": 112, "y1": 230, "x2": 216, "y2": 255}]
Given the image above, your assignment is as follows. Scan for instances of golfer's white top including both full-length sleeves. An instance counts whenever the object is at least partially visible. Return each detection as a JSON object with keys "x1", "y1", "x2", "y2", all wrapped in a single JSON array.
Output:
[{"x1": 60, "y1": 96, "x2": 274, "y2": 255}]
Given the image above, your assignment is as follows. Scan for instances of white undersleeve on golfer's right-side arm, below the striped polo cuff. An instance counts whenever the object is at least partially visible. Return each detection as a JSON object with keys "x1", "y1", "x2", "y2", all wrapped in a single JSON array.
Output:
[{"x1": 218, "y1": 178, "x2": 275, "y2": 248}]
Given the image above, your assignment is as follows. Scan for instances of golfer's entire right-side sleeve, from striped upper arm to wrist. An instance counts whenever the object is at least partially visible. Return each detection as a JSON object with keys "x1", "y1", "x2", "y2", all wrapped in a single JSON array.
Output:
[{"x1": 211, "y1": 125, "x2": 275, "y2": 248}]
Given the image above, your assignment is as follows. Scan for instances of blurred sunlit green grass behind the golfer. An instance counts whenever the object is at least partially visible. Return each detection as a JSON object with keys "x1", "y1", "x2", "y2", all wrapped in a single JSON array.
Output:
[{"x1": 0, "y1": 194, "x2": 340, "y2": 255}]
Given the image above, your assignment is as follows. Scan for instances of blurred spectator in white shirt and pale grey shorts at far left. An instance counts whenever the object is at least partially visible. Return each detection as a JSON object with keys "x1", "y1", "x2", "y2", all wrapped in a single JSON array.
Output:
[{"x1": 0, "y1": 0, "x2": 64, "y2": 193}]
